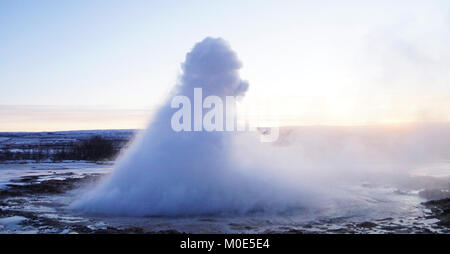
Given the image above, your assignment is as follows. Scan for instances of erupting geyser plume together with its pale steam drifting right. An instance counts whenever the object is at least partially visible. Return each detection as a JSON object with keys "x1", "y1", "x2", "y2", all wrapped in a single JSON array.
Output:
[{"x1": 73, "y1": 38, "x2": 450, "y2": 215}]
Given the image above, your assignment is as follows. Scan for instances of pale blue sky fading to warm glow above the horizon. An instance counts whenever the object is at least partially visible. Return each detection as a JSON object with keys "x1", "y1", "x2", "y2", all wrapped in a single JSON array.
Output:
[{"x1": 0, "y1": 0, "x2": 450, "y2": 131}]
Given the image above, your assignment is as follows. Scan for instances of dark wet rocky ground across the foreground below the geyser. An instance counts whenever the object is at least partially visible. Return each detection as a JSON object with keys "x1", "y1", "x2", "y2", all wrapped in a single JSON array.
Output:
[{"x1": 0, "y1": 172, "x2": 450, "y2": 234}]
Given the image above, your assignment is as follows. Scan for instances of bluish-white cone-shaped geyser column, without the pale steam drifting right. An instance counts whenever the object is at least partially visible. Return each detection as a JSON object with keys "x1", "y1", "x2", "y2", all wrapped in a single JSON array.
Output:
[{"x1": 74, "y1": 38, "x2": 296, "y2": 215}]
